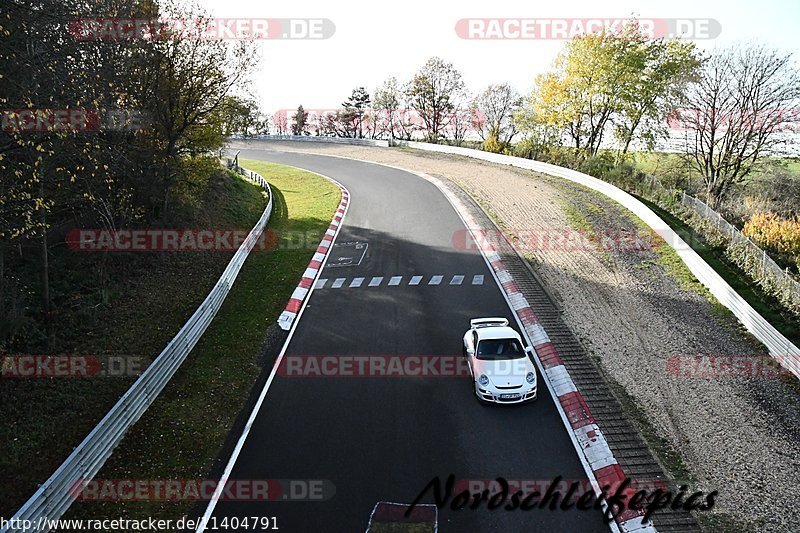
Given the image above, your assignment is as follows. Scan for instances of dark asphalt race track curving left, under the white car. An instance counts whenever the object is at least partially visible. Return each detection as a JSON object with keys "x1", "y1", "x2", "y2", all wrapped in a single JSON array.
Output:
[{"x1": 205, "y1": 150, "x2": 609, "y2": 533}]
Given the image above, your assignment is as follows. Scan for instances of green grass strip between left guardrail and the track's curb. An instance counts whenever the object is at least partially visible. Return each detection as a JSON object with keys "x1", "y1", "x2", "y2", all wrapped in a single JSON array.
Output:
[{"x1": 12, "y1": 161, "x2": 340, "y2": 518}]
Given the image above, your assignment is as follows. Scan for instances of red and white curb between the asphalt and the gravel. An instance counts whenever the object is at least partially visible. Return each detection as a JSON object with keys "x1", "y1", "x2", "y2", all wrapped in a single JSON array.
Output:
[{"x1": 416, "y1": 172, "x2": 656, "y2": 533}]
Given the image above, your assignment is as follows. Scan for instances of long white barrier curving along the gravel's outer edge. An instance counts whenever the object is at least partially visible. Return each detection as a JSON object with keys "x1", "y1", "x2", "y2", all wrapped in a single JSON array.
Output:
[{"x1": 392, "y1": 141, "x2": 800, "y2": 378}]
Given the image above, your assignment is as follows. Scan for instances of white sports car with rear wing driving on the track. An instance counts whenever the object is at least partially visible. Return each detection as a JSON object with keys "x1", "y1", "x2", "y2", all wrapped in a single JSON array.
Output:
[{"x1": 464, "y1": 318, "x2": 536, "y2": 403}]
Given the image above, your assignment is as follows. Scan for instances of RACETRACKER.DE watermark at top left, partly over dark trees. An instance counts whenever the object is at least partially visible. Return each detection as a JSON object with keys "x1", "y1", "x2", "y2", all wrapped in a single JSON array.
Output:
[{"x1": 68, "y1": 18, "x2": 336, "y2": 41}]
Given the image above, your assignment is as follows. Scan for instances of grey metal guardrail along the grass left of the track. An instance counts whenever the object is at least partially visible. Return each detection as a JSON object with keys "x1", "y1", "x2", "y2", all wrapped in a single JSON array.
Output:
[{"x1": 0, "y1": 160, "x2": 273, "y2": 533}]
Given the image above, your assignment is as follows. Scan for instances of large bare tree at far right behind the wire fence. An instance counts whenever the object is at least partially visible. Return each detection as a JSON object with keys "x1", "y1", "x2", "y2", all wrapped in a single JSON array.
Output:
[{"x1": 679, "y1": 45, "x2": 800, "y2": 207}]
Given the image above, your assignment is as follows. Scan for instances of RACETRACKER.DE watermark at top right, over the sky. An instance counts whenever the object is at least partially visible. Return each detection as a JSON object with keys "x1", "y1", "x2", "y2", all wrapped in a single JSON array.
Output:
[{"x1": 455, "y1": 17, "x2": 722, "y2": 41}]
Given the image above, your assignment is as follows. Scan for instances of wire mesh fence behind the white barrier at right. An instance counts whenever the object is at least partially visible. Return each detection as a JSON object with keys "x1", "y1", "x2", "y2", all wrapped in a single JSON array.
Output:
[{"x1": 681, "y1": 192, "x2": 800, "y2": 313}]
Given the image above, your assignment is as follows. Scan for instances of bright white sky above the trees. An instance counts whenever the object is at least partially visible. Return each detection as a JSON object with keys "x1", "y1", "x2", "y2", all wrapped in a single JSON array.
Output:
[{"x1": 195, "y1": 0, "x2": 800, "y2": 112}]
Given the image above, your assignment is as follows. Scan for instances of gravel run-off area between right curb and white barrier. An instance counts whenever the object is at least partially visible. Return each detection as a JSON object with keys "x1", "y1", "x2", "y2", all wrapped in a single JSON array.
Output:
[{"x1": 231, "y1": 141, "x2": 800, "y2": 531}]
